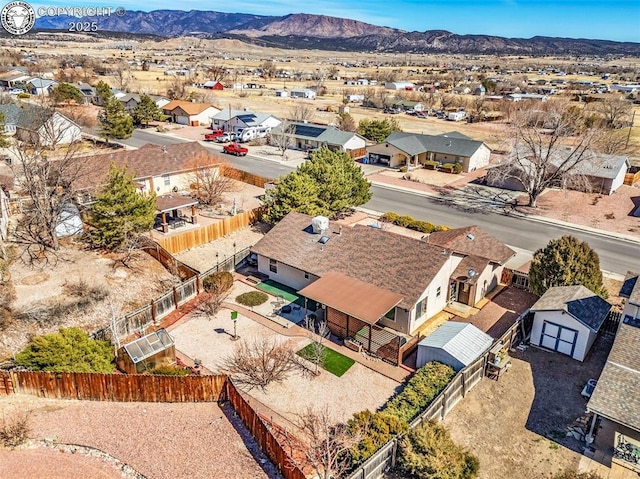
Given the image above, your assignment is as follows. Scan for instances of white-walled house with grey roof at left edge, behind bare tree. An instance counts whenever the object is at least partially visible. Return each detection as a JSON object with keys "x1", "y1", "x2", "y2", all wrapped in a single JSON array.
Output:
[{"x1": 0, "y1": 103, "x2": 82, "y2": 146}]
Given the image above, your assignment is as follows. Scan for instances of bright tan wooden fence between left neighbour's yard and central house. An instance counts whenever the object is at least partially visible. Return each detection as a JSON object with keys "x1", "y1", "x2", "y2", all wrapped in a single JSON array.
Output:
[{"x1": 157, "y1": 208, "x2": 262, "y2": 254}]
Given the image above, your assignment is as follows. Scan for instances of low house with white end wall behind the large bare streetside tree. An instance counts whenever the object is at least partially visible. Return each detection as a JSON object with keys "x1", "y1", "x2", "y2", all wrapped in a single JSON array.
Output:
[{"x1": 486, "y1": 149, "x2": 631, "y2": 195}]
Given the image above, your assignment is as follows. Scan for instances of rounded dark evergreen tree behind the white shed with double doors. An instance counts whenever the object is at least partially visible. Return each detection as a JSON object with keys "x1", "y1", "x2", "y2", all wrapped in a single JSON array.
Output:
[{"x1": 529, "y1": 236, "x2": 607, "y2": 298}]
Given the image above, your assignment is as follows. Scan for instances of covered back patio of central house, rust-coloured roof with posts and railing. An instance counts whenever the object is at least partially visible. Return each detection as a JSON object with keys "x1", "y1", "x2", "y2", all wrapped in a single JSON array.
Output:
[{"x1": 299, "y1": 272, "x2": 413, "y2": 366}]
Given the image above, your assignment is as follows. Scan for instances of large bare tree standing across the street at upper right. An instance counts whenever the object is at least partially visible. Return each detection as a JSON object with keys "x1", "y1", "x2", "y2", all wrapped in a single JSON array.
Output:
[{"x1": 488, "y1": 102, "x2": 597, "y2": 207}]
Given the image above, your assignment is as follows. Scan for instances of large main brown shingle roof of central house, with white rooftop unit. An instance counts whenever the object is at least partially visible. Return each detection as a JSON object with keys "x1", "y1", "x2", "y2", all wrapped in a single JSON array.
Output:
[{"x1": 252, "y1": 212, "x2": 449, "y2": 309}]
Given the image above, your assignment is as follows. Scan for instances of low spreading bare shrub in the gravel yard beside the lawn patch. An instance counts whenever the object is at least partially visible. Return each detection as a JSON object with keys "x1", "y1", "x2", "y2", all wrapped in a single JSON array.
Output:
[{"x1": 221, "y1": 337, "x2": 301, "y2": 391}]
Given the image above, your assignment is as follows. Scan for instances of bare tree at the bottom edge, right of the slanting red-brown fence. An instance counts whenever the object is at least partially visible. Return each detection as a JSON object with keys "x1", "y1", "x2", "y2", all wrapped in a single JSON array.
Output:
[{"x1": 284, "y1": 407, "x2": 362, "y2": 479}]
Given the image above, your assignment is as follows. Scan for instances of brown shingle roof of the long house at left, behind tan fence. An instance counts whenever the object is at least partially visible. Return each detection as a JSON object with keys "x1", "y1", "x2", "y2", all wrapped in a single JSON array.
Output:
[{"x1": 74, "y1": 141, "x2": 220, "y2": 189}]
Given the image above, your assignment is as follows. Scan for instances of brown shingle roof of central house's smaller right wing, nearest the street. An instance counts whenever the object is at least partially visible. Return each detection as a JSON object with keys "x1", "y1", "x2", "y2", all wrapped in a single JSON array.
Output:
[{"x1": 427, "y1": 225, "x2": 515, "y2": 264}]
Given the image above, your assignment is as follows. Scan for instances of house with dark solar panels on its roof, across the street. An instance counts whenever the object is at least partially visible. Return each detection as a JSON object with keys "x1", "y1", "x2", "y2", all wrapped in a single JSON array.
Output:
[{"x1": 272, "y1": 122, "x2": 366, "y2": 158}]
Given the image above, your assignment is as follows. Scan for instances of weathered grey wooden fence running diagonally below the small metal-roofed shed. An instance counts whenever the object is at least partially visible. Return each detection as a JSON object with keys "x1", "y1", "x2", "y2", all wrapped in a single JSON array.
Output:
[{"x1": 349, "y1": 316, "x2": 529, "y2": 479}]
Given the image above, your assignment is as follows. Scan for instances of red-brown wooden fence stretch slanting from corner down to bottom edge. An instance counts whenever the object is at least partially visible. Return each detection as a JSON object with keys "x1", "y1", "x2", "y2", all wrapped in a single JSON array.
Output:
[{"x1": 226, "y1": 381, "x2": 305, "y2": 479}]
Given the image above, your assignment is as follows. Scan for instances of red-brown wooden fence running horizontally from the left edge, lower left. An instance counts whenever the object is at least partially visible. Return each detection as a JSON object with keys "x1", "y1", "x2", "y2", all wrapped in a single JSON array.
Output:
[{"x1": 0, "y1": 371, "x2": 227, "y2": 402}]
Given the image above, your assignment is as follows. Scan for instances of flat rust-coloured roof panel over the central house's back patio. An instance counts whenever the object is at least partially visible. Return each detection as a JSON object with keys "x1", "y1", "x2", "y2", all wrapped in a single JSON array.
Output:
[{"x1": 298, "y1": 271, "x2": 403, "y2": 324}]
